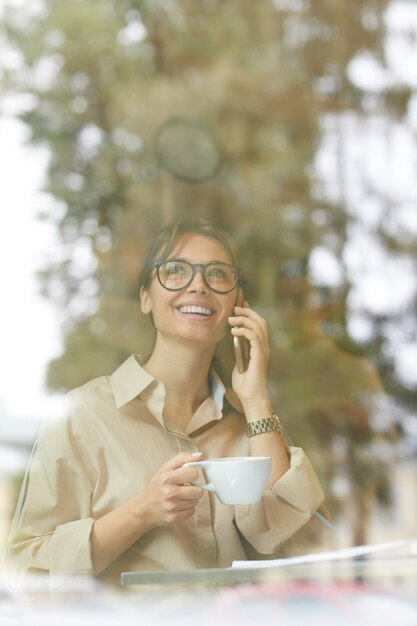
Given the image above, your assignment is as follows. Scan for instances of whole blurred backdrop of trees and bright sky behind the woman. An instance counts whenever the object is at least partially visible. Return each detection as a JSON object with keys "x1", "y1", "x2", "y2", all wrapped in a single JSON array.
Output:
[{"x1": 0, "y1": 0, "x2": 417, "y2": 547}]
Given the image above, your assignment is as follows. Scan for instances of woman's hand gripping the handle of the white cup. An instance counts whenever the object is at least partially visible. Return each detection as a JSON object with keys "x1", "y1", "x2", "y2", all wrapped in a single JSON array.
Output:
[{"x1": 138, "y1": 452, "x2": 204, "y2": 528}]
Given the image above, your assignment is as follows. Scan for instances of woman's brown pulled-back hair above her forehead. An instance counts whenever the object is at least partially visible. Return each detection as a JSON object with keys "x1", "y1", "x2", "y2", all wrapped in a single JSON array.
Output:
[{"x1": 139, "y1": 219, "x2": 241, "y2": 289}]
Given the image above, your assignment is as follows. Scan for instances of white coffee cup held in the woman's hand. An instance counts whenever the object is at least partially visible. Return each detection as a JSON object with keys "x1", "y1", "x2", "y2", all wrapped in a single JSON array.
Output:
[{"x1": 183, "y1": 456, "x2": 271, "y2": 504}]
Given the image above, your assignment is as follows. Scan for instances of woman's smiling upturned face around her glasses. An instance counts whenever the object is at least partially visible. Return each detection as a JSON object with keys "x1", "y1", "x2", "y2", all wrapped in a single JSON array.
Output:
[{"x1": 140, "y1": 233, "x2": 237, "y2": 345}]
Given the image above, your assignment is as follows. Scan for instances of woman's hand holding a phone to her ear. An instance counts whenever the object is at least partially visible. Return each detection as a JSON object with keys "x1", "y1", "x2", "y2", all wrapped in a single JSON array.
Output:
[{"x1": 229, "y1": 302, "x2": 269, "y2": 405}]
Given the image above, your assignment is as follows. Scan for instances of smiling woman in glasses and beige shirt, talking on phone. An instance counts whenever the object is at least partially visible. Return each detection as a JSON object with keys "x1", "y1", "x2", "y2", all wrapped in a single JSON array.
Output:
[{"x1": 9, "y1": 221, "x2": 323, "y2": 582}]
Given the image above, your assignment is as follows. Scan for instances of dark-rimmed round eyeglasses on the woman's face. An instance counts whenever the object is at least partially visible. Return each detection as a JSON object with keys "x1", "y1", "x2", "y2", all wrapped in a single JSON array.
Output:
[{"x1": 153, "y1": 259, "x2": 240, "y2": 293}]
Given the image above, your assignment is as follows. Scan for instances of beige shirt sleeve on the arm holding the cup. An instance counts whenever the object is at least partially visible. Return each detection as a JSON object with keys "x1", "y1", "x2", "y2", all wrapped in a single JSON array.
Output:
[{"x1": 6, "y1": 422, "x2": 94, "y2": 576}]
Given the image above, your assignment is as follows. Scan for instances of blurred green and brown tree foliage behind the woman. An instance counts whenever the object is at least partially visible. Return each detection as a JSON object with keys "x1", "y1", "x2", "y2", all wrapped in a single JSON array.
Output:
[{"x1": 3, "y1": 0, "x2": 416, "y2": 542}]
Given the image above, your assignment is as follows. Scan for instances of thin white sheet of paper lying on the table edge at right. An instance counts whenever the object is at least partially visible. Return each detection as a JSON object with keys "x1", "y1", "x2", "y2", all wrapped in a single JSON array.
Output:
[{"x1": 232, "y1": 540, "x2": 417, "y2": 569}]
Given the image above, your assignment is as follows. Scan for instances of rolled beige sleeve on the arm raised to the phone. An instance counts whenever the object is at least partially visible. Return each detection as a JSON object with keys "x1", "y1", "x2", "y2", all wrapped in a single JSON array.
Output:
[{"x1": 235, "y1": 447, "x2": 324, "y2": 555}]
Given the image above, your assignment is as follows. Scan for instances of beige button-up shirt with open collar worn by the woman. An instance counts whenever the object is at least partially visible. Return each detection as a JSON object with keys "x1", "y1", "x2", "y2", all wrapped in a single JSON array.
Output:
[{"x1": 8, "y1": 355, "x2": 323, "y2": 583}]
